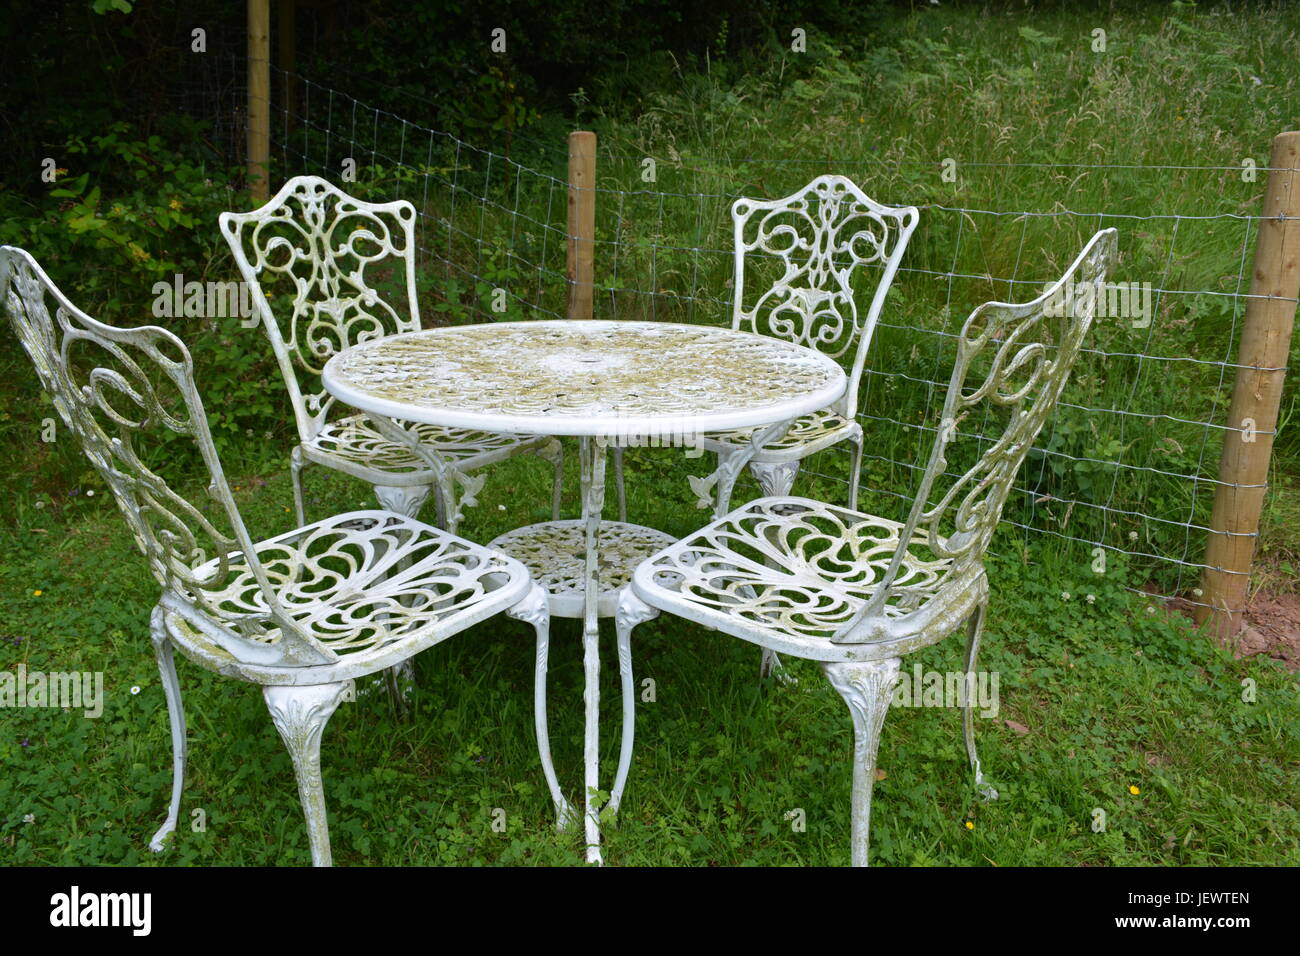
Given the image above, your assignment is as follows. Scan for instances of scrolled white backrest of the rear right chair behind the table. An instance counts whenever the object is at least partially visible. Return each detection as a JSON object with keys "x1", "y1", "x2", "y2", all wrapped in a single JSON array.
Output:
[{"x1": 732, "y1": 176, "x2": 920, "y2": 418}]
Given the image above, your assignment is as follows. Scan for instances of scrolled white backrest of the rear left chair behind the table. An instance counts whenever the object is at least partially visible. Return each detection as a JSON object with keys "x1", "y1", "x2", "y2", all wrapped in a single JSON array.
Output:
[{"x1": 221, "y1": 176, "x2": 420, "y2": 441}]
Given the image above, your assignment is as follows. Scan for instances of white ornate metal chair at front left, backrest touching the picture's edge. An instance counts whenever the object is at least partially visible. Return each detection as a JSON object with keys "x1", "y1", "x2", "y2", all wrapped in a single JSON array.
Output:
[{"x1": 0, "y1": 246, "x2": 566, "y2": 866}]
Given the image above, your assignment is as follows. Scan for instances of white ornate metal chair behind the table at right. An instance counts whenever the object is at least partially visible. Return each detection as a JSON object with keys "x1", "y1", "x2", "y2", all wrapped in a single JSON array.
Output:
[{"x1": 688, "y1": 176, "x2": 920, "y2": 518}]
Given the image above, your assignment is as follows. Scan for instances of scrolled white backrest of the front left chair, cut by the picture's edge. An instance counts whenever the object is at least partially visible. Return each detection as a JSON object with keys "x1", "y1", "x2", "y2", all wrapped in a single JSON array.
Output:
[{"x1": 0, "y1": 246, "x2": 337, "y2": 665}]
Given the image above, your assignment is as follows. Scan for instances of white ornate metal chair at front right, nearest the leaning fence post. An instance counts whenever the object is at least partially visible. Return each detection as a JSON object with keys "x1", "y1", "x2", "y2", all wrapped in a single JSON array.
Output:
[{"x1": 616, "y1": 229, "x2": 1117, "y2": 866}]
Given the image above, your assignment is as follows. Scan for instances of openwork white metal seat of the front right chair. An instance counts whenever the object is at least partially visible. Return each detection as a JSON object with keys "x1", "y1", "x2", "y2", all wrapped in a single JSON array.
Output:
[{"x1": 633, "y1": 497, "x2": 980, "y2": 661}]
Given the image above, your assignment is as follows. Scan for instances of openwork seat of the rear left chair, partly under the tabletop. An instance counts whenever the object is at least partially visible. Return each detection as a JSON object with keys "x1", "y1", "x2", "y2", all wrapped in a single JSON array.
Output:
[{"x1": 303, "y1": 415, "x2": 550, "y2": 484}]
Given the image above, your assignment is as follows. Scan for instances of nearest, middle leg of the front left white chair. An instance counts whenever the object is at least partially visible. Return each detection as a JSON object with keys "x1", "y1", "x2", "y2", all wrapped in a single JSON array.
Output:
[{"x1": 261, "y1": 680, "x2": 348, "y2": 866}]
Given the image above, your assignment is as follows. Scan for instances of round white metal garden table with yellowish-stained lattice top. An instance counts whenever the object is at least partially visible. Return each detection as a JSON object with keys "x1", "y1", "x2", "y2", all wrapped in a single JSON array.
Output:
[{"x1": 322, "y1": 320, "x2": 848, "y2": 862}]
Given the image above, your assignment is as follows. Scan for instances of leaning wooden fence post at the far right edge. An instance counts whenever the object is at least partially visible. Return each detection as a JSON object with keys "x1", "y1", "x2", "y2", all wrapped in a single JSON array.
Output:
[{"x1": 1196, "y1": 131, "x2": 1300, "y2": 641}]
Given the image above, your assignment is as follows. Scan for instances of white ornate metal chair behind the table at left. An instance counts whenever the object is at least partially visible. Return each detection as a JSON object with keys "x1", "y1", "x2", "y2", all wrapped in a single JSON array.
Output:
[{"x1": 221, "y1": 176, "x2": 563, "y2": 532}]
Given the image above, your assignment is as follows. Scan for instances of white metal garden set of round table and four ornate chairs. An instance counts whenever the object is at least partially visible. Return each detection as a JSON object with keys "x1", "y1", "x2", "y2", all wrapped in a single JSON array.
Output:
[{"x1": 0, "y1": 167, "x2": 1117, "y2": 865}]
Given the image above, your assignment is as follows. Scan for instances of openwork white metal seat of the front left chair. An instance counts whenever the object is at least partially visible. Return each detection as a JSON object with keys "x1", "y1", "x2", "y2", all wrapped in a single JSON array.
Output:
[{"x1": 169, "y1": 511, "x2": 530, "y2": 679}]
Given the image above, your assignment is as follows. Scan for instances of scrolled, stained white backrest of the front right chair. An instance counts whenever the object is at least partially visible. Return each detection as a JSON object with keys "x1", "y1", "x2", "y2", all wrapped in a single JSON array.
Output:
[{"x1": 835, "y1": 229, "x2": 1118, "y2": 643}]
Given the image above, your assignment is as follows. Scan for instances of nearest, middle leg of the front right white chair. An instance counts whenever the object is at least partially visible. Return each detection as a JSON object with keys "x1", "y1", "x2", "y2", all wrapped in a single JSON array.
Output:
[{"x1": 822, "y1": 657, "x2": 898, "y2": 866}]
